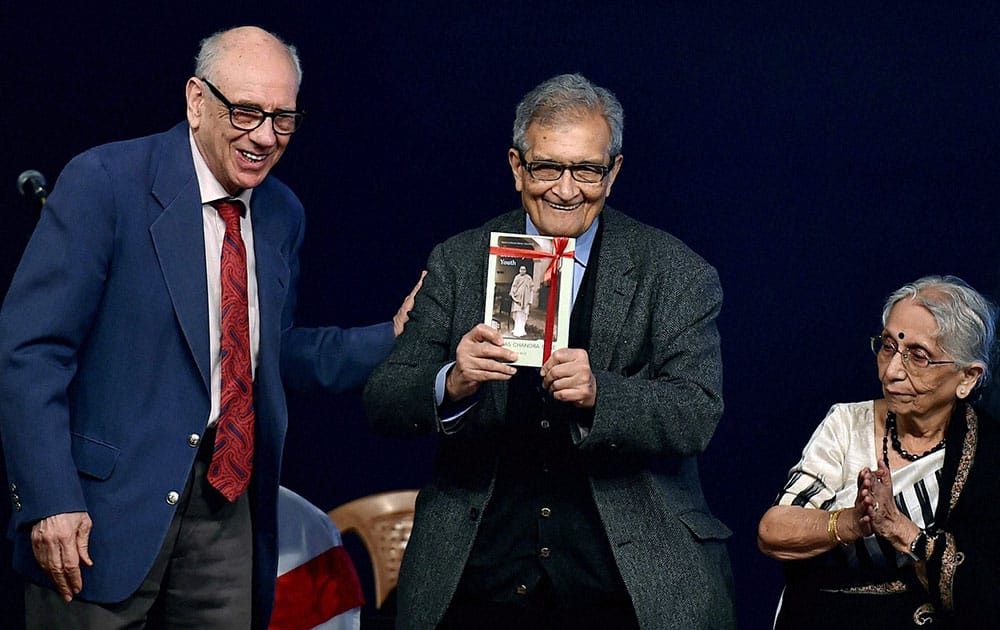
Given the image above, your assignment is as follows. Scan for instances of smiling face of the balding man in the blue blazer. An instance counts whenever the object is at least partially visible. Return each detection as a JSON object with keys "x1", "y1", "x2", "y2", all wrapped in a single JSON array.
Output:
[{"x1": 186, "y1": 29, "x2": 298, "y2": 195}]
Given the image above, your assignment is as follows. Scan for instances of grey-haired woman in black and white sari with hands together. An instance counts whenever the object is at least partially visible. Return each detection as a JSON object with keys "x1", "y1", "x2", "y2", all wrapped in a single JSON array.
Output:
[{"x1": 758, "y1": 276, "x2": 1000, "y2": 630}]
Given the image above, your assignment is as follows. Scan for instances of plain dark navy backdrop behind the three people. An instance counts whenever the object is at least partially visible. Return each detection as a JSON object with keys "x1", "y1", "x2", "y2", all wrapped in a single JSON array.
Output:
[{"x1": 0, "y1": 0, "x2": 1000, "y2": 628}]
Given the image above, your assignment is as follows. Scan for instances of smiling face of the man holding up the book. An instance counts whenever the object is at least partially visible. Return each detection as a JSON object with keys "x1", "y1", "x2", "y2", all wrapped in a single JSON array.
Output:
[{"x1": 508, "y1": 112, "x2": 622, "y2": 237}]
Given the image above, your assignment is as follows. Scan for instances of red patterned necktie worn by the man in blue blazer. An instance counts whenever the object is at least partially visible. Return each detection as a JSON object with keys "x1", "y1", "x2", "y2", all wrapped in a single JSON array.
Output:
[{"x1": 208, "y1": 199, "x2": 254, "y2": 501}]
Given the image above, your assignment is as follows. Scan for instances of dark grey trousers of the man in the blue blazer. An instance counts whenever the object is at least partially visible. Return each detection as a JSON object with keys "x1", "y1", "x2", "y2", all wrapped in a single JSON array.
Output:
[{"x1": 24, "y1": 431, "x2": 253, "y2": 630}]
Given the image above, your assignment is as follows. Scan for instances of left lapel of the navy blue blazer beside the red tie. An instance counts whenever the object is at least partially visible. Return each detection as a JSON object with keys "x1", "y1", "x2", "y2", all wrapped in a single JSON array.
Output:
[{"x1": 149, "y1": 123, "x2": 211, "y2": 389}]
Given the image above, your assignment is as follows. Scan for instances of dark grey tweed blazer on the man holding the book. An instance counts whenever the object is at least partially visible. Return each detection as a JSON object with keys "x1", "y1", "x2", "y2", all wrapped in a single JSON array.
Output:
[{"x1": 365, "y1": 208, "x2": 735, "y2": 630}]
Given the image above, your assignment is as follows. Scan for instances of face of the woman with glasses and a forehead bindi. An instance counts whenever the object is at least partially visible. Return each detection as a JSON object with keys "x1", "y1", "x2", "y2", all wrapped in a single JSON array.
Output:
[{"x1": 878, "y1": 299, "x2": 982, "y2": 421}]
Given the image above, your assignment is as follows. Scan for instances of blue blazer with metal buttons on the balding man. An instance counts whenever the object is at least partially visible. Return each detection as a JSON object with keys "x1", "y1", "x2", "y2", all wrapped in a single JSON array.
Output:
[{"x1": 0, "y1": 123, "x2": 393, "y2": 627}]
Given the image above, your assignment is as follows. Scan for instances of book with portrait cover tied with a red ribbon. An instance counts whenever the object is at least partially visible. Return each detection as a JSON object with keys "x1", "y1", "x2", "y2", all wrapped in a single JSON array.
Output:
[{"x1": 485, "y1": 232, "x2": 576, "y2": 367}]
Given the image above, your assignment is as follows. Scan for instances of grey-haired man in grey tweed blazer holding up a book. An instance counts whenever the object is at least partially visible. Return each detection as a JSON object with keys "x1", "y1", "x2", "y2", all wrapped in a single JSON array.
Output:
[{"x1": 365, "y1": 75, "x2": 735, "y2": 630}]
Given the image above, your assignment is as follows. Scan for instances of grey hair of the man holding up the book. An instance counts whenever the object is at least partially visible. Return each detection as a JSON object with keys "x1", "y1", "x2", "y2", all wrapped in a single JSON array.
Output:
[{"x1": 513, "y1": 74, "x2": 625, "y2": 155}]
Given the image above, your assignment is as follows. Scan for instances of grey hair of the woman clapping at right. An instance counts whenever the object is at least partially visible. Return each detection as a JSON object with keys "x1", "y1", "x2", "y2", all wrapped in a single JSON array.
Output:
[{"x1": 882, "y1": 276, "x2": 997, "y2": 387}]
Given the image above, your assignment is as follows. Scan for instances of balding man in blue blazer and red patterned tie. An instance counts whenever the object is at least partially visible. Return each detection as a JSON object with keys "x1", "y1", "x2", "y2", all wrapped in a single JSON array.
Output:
[{"x1": 0, "y1": 27, "x2": 414, "y2": 628}]
